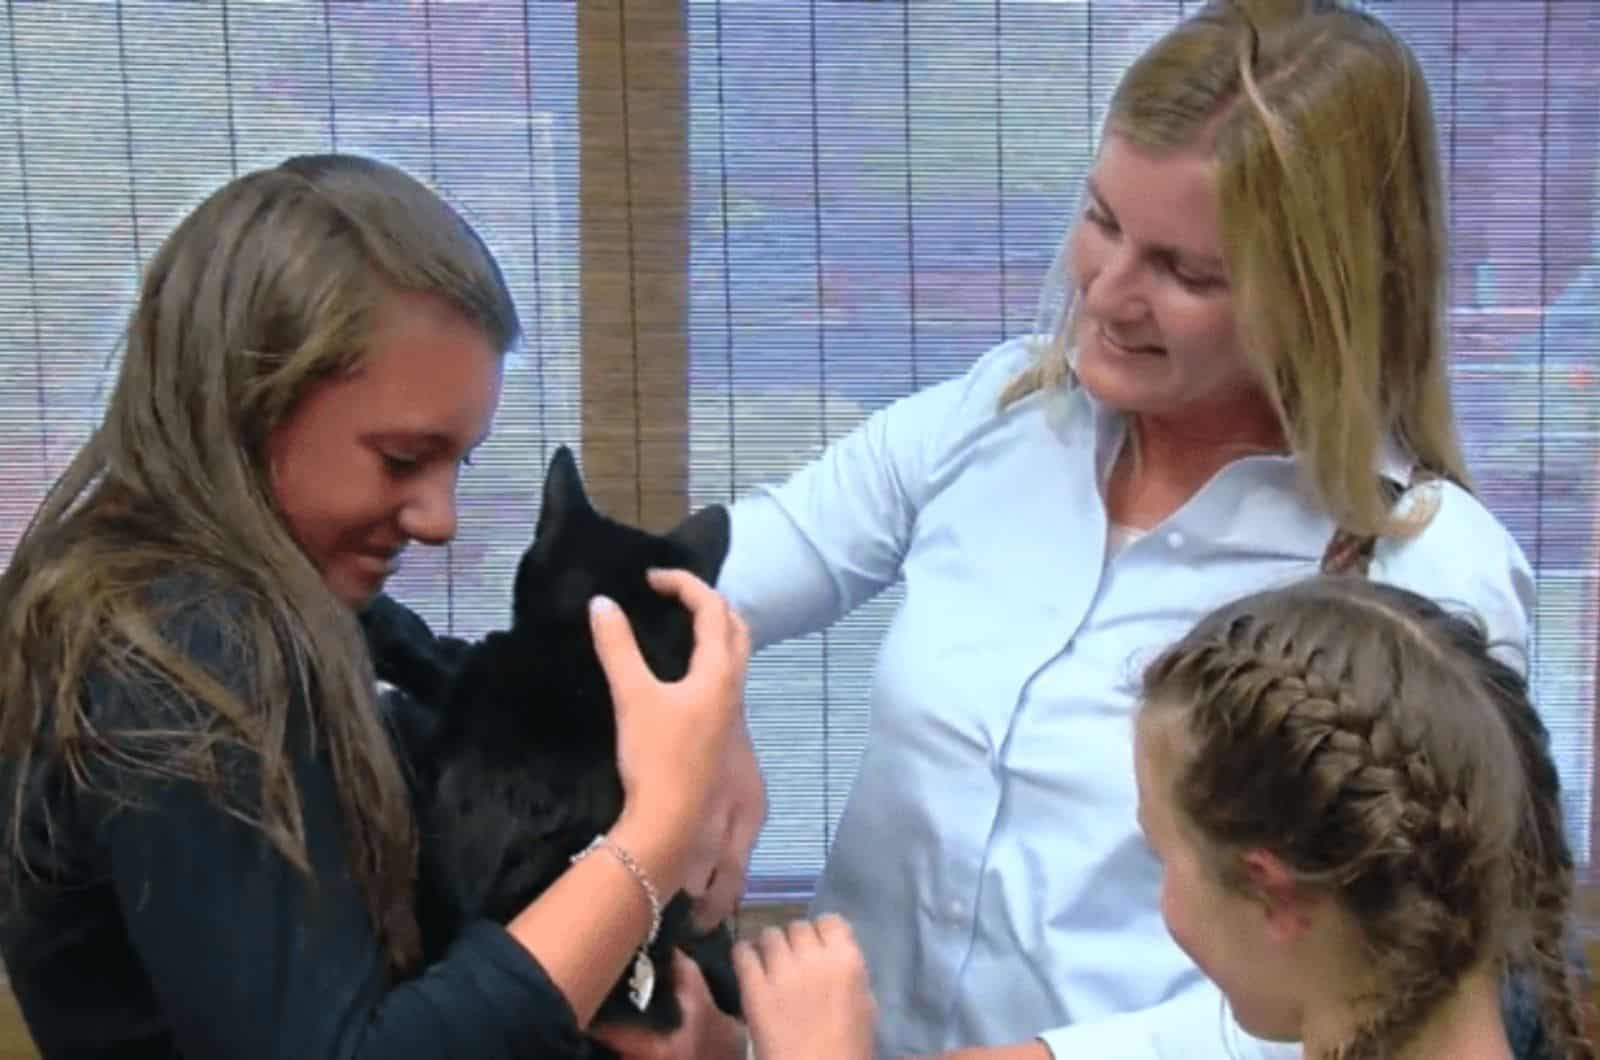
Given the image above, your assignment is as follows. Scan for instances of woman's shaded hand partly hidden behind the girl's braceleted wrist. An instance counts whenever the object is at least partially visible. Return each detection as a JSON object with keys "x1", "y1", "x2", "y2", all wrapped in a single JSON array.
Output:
[{"x1": 685, "y1": 725, "x2": 766, "y2": 932}]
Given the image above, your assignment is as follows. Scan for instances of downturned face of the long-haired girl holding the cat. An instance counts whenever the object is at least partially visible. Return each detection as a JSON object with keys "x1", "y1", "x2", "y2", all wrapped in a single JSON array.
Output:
[{"x1": 267, "y1": 293, "x2": 502, "y2": 607}]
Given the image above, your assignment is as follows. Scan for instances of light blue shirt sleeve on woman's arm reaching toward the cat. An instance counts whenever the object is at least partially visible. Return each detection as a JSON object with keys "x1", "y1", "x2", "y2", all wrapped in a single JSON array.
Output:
[{"x1": 717, "y1": 339, "x2": 1029, "y2": 648}]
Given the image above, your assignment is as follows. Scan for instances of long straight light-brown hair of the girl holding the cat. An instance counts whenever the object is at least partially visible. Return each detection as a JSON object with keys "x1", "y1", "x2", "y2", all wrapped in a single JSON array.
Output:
[{"x1": 0, "y1": 155, "x2": 518, "y2": 969}]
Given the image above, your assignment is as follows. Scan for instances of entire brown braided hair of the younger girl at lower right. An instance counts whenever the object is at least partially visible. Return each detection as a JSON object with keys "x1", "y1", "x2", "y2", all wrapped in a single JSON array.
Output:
[{"x1": 1139, "y1": 578, "x2": 1592, "y2": 1058}]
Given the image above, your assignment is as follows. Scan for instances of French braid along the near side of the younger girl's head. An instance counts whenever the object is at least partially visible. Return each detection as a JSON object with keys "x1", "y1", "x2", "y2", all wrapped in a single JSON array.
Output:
[{"x1": 1163, "y1": 618, "x2": 1509, "y2": 1060}]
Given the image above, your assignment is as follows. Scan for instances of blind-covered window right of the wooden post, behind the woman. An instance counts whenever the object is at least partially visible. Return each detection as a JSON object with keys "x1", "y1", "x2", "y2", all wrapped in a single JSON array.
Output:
[{"x1": 688, "y1": 0, "x2": 1600, "y2": 897}]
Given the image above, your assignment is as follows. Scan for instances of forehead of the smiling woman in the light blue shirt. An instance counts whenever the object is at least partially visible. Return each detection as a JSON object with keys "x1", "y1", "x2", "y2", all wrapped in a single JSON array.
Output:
[{"x1": 1090, "y1": 133, "x2": 1222, "y2": 258}]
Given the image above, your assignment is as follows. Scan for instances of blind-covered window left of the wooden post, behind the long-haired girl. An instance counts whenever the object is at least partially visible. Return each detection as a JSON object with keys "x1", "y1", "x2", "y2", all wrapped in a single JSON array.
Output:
[{"x1": 0, "y1": 0, "x2": 579, "y2": 636}]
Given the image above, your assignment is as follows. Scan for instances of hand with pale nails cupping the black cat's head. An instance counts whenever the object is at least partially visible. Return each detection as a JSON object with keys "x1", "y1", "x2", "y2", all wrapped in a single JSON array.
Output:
[{"x1": 590, "y1": 570, "x2": 750, "y2": 893}]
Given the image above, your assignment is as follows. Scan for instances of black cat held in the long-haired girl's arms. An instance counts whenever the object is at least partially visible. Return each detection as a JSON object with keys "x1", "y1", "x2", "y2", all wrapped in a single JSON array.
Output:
[{"x1": 362, "y1": 447, "x2": 739, "y2": 1055}]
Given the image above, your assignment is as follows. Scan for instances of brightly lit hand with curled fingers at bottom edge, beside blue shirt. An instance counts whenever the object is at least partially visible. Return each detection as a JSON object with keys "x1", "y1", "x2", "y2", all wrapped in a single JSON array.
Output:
[{"x1": 733, "y1": 914, "x2": 877, "y2": 1060}]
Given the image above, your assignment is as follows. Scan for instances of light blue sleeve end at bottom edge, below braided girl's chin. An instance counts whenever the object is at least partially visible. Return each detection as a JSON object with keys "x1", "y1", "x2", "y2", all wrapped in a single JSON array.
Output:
[{"x1": 1038, "y1": 980, "x2": 1301, "y2": 1060}]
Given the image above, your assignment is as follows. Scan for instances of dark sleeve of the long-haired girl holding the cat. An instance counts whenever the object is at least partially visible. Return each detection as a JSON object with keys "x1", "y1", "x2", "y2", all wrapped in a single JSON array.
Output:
[{"x1": 84, "y1": 598, "x2": 579, "y2": 1060}]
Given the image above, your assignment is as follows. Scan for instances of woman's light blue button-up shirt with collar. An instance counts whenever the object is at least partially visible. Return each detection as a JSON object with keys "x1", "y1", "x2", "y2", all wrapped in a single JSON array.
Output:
[{"x1": 718, "y1": 341, "x2": 1533, "y2": 1060}]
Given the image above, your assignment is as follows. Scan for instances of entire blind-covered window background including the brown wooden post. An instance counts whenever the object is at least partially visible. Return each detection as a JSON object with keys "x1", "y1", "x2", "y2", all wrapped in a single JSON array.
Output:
[{"x1": 0, "y1": 0, "x2": 1600, "y2": 897}]
